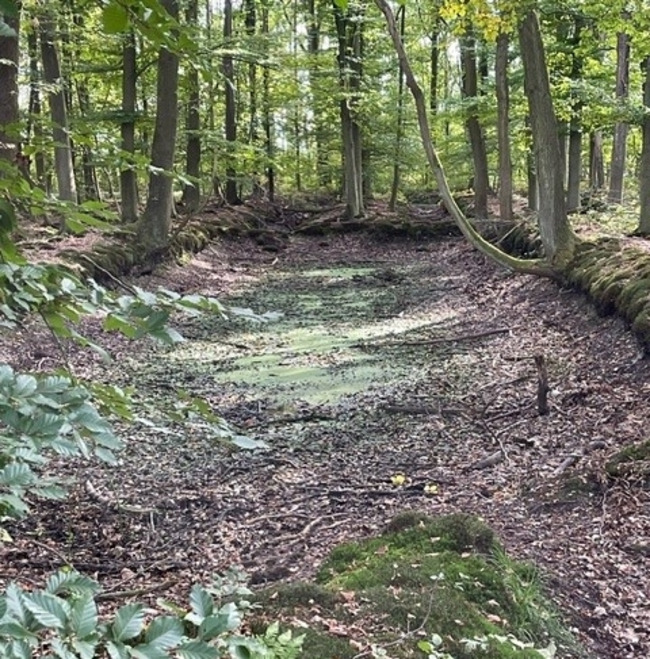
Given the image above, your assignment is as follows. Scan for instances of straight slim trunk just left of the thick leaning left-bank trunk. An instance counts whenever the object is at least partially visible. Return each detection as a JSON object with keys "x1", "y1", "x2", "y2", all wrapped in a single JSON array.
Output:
[{"x1": 120, "y1": 30, "x2": 138, "y2": 224}]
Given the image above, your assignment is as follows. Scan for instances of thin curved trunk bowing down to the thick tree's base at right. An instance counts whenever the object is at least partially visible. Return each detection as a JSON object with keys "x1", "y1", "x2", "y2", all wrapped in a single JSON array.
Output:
[{"x1": 375, "y1": 0, "x2": 557, "y2": 278}]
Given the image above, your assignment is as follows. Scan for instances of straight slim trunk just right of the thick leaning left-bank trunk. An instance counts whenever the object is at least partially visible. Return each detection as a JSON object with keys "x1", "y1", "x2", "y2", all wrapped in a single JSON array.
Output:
[{"x1": 182, "y1": 0, "x2": 201, "y2": 213}]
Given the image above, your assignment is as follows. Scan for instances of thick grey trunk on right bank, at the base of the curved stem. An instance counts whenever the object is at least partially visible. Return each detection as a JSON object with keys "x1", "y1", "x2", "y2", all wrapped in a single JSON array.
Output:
[{"x1": 519, "y1": 9, "x2": 575, "y2": 266}]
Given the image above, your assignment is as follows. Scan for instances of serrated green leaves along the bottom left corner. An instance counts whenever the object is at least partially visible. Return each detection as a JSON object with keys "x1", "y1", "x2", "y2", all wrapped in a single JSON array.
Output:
[{"x1": 0, "y1": 571, "x2": 302, "y2": 659}]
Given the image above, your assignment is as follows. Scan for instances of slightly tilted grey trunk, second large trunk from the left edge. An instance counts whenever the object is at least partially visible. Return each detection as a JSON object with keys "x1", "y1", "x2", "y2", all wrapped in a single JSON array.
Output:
[{"x1": 39, "y1": 7, "x2": 77, "y2": 201}]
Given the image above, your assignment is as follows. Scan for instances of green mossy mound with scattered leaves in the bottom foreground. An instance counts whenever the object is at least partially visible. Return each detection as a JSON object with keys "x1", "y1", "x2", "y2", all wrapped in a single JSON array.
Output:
[{"x1": 248, "y1": 513, "x2": 580, "y2": 659}]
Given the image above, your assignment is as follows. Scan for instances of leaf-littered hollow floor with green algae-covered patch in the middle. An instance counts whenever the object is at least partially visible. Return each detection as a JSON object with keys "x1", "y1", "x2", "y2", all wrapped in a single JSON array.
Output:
[{"x1": 0, "y1": 229, "x2": 650, "y2": 659}]
